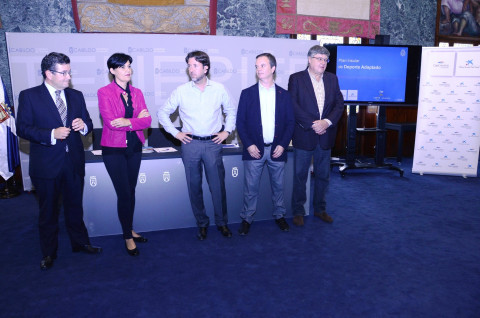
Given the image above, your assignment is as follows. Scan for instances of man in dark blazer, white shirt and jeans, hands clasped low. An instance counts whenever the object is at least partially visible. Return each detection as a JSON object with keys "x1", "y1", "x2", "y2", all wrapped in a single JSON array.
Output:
[{"x1": 237, "y1": 53, "x2": 295, "y2": 235}]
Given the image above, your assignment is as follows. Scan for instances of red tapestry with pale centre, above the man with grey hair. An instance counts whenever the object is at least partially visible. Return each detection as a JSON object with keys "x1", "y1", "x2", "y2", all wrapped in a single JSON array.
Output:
[{"x1": 276, "y1": 0, "x2": 380, "y2": 39}]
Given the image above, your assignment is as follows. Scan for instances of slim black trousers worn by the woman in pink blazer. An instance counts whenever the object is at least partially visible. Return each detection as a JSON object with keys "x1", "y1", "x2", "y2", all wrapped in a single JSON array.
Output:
[{"x1": 103, "y1": 149, "x2": 142, "y2": 239}]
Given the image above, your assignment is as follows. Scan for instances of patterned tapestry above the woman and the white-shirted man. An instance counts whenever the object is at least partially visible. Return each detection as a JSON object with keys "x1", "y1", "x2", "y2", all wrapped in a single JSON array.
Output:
[{"x1": 72, "y1": 0, "x2": 217, "y2": 34}]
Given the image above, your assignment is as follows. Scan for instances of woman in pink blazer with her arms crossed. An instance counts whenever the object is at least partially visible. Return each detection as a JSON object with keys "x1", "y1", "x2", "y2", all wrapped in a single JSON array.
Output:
[{"x1": 98, "y1": 53, "x2": 152, "y2": 256}]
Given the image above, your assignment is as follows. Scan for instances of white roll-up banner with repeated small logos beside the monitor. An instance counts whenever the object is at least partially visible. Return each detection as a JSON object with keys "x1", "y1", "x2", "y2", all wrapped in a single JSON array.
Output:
[{"x1": 412, "y1": 47, "x2": 480, "y2": 177}]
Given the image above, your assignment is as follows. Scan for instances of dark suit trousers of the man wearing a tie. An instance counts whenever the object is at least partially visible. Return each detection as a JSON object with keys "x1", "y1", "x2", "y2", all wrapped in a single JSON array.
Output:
[{"x1": 31, "y1": 153, "x2": 90, "y2": 257}]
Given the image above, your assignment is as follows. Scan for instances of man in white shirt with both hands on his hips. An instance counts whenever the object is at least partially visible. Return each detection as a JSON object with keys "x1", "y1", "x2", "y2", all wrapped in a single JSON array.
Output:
[{"x1": 157, "y1": 51, "x2": 237, "y2": 241}]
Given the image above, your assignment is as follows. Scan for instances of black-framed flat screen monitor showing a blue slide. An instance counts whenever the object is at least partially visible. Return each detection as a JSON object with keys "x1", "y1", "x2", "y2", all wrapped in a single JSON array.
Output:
[{"x1": 325, "y1": 45, "x2": 422, "y2": 106}]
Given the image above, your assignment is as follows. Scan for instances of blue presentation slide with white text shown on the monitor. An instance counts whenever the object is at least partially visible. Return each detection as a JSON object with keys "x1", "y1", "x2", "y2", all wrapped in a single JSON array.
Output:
[{"x1": 336, "y1": 46, "x2": 408, "y2": 102}]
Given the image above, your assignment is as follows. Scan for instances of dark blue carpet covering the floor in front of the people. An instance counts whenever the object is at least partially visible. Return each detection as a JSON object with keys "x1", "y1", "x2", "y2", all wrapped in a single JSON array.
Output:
[{"x1": 0, "y1": 159, "x2": 480, "y2": 318}]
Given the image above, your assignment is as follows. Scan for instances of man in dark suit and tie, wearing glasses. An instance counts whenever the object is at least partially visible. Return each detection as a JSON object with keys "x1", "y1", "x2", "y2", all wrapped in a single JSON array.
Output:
[{"x1": 17, "y1": 52, "x2": 101, "y2": 270}]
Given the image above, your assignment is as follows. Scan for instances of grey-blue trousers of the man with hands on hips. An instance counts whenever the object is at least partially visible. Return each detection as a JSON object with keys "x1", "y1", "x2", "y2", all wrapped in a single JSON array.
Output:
[{"x1": 182, "y1": 140, "x2": 228, "y2": 227}]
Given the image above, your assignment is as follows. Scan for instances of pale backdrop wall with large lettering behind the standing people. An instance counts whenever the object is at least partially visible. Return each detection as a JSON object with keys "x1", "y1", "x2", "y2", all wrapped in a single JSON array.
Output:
[{"x1": 5, "y1": 32, "x2": 318, "y2": 190}]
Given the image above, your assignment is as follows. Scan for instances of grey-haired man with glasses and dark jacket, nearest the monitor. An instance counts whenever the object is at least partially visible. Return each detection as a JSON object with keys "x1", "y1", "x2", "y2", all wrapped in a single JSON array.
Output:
[{"x1": 288, "y1": 45, "x2": 343, "y2": 226}]
